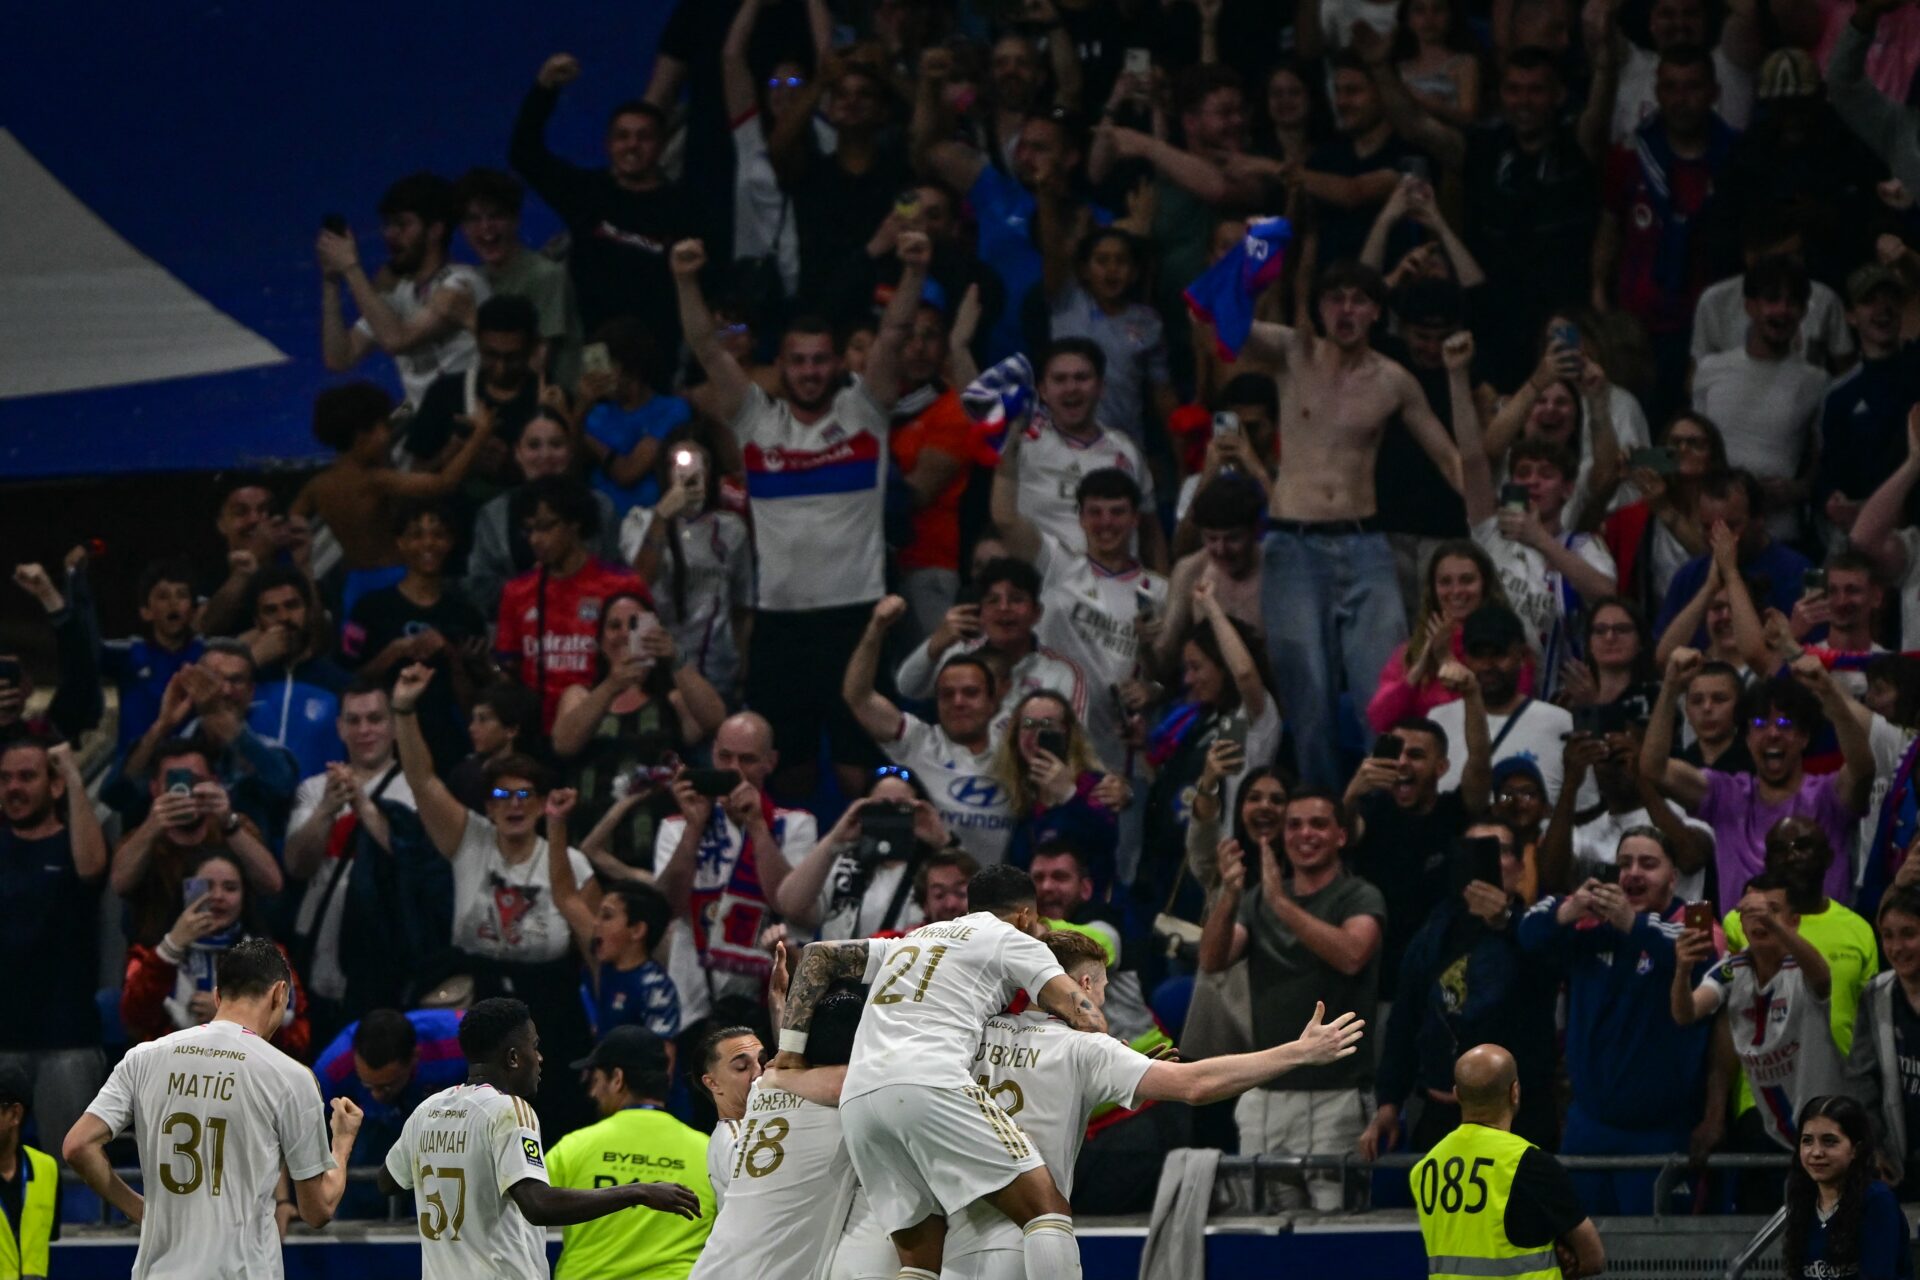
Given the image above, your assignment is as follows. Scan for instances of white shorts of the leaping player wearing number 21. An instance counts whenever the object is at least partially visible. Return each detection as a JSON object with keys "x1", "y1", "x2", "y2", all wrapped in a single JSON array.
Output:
[{"x1": 839, "y1": 1084, "x2": 1046, "y2": 1234}]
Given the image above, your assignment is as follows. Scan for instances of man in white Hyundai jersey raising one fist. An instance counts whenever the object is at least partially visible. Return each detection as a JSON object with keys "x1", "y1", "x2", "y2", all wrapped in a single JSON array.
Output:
[{"x1": 841, "y1": 598, "x2": 1039, "y2": 864}]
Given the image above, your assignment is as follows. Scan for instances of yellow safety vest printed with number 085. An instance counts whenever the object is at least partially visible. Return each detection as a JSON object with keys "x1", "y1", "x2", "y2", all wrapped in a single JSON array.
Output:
[{"x1": 1409, "y1": 1125, "x2": 1561, "y2": 1280}]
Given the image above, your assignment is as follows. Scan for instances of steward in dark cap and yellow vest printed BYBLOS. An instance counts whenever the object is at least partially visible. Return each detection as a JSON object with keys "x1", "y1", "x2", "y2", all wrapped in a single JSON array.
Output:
[{"x1": 547, "y1": 1025, "x2": 714, "y2": 1280}]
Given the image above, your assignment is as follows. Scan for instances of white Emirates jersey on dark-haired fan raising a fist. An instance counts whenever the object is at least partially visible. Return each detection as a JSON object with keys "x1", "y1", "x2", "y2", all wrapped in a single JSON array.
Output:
[{"x1": 1033, "y1": 533, "x2": 1167, "y2": 770}]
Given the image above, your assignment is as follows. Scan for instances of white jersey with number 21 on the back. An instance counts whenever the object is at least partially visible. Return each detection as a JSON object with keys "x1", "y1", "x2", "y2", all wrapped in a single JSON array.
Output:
[{"x1": 841, "y1": 912, "x2": 1060, "y2": 1103}]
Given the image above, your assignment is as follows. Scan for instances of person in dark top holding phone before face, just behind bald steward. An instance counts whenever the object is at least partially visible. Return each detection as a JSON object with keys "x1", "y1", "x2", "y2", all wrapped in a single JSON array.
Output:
[{"x1": 1359, "y1": 821, "x2": 1559, "y2": 1159}]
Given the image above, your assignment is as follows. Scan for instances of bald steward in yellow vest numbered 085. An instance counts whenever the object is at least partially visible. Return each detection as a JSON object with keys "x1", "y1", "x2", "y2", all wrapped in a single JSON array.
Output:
[{"x1": 1411, "y1": 1044, "x2": 1607, "y2": 1280}]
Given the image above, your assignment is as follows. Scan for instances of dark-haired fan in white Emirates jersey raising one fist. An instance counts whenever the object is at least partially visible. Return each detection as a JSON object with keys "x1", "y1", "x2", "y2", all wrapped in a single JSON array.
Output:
[{"x1": 993, "y1": 436, "x2": 1167, "y2": 770}]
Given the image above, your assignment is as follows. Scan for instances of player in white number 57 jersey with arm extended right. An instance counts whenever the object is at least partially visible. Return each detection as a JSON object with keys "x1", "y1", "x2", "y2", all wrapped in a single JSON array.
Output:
[{"x1": 380, "y1": 998, "x2": 701, "y2": 1280}]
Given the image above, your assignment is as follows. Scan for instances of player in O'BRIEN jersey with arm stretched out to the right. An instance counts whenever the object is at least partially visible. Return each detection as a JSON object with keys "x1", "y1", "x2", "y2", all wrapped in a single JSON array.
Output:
[{"x1": 941, "y1": 929, "x2": 1365, "y2": 1280}]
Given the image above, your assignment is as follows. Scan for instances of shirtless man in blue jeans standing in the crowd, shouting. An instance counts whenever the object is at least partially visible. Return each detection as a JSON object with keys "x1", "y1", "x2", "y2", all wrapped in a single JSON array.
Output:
[{"x1": 1242, "y1": 263, "x2": 1473, "y2": 787}]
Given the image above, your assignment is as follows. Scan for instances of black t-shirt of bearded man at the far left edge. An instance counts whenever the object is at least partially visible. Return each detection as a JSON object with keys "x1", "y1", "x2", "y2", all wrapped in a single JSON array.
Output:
[{"x1": 0, "y1": 823, "x2": 100, "y2": 1052}]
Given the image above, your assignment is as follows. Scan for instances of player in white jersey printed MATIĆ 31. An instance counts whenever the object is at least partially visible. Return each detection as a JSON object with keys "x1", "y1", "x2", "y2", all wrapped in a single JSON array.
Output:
[{"x1": 61, "y1": 938, "x2": 361, "y2": 1280}]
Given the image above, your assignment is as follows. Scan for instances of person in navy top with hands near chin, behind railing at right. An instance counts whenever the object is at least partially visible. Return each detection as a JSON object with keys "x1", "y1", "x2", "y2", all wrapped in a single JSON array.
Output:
[{"x1": 1519, "y1": 827, "x2": 1713, "y2": 1215}]
